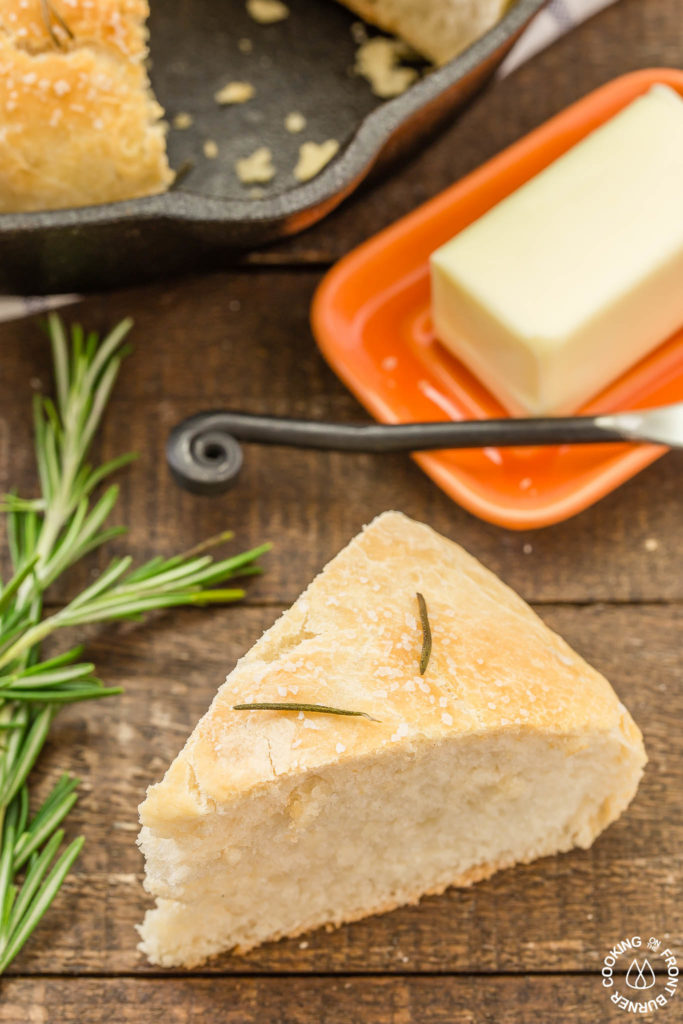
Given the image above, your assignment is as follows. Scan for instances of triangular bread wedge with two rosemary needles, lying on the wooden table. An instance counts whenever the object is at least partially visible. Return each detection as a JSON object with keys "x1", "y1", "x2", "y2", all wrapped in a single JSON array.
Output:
[{"x1": 139, "y1": 512, "x2": 645, "y2": 966}]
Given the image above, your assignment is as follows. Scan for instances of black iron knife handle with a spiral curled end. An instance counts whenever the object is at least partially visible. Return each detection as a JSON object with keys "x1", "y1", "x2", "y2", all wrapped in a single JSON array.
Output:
[{"x1": 166, "y1": 411, "x2": 625, "y2": 495}]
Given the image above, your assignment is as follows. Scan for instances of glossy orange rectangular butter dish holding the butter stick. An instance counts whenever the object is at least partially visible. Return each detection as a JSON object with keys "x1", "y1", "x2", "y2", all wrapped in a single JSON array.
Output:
[{"x1": 312, "y1": 69, "x2": 683, "y2": 529}]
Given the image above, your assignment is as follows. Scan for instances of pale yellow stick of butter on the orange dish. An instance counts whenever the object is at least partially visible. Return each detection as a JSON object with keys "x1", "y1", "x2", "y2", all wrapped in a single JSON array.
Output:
[{"x1": 431, "y1": 85, "x2": 683, "y2": 416}]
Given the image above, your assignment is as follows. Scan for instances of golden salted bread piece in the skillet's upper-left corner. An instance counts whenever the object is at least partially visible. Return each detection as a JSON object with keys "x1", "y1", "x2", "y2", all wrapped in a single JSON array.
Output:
[{"x1": 0, "y1": 0, "x2": 173, "y2": 212}]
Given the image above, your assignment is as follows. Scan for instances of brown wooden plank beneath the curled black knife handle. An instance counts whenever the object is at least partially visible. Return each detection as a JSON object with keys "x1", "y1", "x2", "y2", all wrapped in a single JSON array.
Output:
[{"x1": 0, "y1": 271, "x2": 683, "y2": 602}]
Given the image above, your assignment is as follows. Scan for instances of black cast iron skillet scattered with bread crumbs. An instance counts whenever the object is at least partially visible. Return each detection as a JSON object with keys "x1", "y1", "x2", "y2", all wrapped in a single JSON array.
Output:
[{"x1": 0, "y1": 0, "x2": 546, "y2": 294}]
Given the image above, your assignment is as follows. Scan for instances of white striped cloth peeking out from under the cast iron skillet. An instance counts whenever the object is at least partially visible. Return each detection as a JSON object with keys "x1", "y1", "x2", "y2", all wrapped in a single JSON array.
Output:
[{"x1": 0, "y1": 0, "x2": 614, "y2": 323}]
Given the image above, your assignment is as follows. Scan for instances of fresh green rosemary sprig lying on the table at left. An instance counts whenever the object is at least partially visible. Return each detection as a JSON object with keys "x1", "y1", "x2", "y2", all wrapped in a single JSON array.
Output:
[{"x1": 0, "y1": 314, "x2": 268, "y2": 973}]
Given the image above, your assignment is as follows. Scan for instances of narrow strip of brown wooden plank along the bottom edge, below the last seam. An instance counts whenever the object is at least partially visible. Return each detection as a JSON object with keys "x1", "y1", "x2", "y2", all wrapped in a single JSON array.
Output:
[{"x1": 0, "y1": 975, "x2": 675, "y2": 1024}]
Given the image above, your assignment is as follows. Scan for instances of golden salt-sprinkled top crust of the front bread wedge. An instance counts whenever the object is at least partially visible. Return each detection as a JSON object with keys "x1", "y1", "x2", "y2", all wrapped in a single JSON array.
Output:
[{"x1": 140, "y1": 512, "x2": 642, "y2": 833}]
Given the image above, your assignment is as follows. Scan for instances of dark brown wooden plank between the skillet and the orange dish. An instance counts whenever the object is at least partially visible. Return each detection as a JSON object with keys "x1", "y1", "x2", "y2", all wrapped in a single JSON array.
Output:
[{"x1": 259, "y1": 0, "x2": 683, "y2": 265}]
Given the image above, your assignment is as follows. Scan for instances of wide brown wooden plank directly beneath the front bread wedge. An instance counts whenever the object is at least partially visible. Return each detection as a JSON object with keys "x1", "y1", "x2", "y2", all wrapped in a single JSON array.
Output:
[{"x1": 7, "y1": 606, "x2": 683, "y2": 974}]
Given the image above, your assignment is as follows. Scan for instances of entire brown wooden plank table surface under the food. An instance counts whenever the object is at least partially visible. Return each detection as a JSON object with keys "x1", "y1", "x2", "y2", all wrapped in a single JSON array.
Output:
[{"x1": 0, "y1": 0, "x2": 683, "y2": 1024}]
